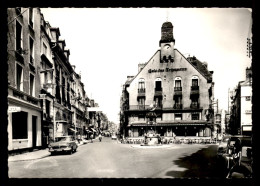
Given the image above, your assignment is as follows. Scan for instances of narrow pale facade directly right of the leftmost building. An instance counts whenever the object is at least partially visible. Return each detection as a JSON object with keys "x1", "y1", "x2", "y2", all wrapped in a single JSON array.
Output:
[{"x1": 39, "y1": 14, "x2": 55, "y2": 146}]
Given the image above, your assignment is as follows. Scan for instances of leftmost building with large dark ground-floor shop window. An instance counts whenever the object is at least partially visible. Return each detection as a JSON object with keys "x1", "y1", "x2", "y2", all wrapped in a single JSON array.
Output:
[{"x1": 7, "y1": 8, "x2": 42, "y2": 151}]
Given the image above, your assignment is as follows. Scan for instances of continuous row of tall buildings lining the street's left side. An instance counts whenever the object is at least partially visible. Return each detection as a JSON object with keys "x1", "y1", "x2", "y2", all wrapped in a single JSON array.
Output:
[{"x1": 7, "y1": 8, "x2": 99, "y2": 152}]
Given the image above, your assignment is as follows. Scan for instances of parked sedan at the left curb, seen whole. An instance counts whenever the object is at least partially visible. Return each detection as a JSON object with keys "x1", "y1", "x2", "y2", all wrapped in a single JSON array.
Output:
[{"x1": 49, "y1": 136, "x2": 78, "y2": 155}]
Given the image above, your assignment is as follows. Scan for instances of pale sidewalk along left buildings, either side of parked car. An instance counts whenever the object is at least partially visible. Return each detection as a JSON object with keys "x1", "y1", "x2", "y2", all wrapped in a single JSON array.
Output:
[{"x1": 8, "y1": 143, "x2": 89, "y2": 162}]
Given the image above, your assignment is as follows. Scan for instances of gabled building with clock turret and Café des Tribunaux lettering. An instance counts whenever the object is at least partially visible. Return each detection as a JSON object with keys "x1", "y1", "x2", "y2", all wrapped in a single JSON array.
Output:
[{"x1": 121, "y1": 22, "x2": 214, "y2": 137}]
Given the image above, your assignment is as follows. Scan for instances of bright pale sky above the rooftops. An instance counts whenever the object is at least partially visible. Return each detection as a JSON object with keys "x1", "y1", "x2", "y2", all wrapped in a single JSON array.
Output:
[{"x1": 41, "y1": 8, "x2": 251, "y2": 124}]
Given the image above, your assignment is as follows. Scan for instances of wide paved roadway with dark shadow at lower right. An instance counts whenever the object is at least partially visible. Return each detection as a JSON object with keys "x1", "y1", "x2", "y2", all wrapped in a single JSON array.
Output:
[{"x1": 8, "y1": 137, "x2": 225, "y2": 178}]
